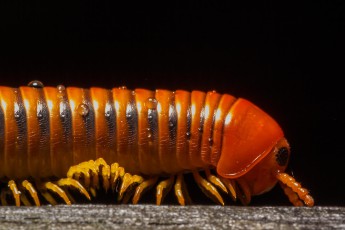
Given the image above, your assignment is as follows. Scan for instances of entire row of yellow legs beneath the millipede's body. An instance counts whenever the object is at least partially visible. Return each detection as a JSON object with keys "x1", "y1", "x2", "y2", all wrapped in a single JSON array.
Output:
[{"x1": 0, "y1": 158, "x2": 238, "y2": 206}]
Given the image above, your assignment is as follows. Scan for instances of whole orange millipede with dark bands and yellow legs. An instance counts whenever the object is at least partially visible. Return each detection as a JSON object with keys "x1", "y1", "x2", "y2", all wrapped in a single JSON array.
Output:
[{"x1": 0, "y1": 80, "x2": 314, "y2": 206}]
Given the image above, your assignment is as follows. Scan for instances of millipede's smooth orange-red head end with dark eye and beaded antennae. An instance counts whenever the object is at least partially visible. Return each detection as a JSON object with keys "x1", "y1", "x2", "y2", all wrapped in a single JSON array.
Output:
[{"x1": 217, "y1": 99, "x2": 314, "y2": 206}]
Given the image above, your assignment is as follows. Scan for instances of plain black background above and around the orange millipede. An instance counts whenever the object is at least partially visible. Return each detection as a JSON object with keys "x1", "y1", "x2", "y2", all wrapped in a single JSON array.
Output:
[{"x1": 0, "y1": 1, "x2": 345, "y2": 206}]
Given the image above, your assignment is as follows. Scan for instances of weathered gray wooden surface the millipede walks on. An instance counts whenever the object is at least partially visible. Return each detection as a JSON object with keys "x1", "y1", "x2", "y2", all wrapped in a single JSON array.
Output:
[{"x1": 0, "y1": 205, "x2": 345, "y2": 229}]
